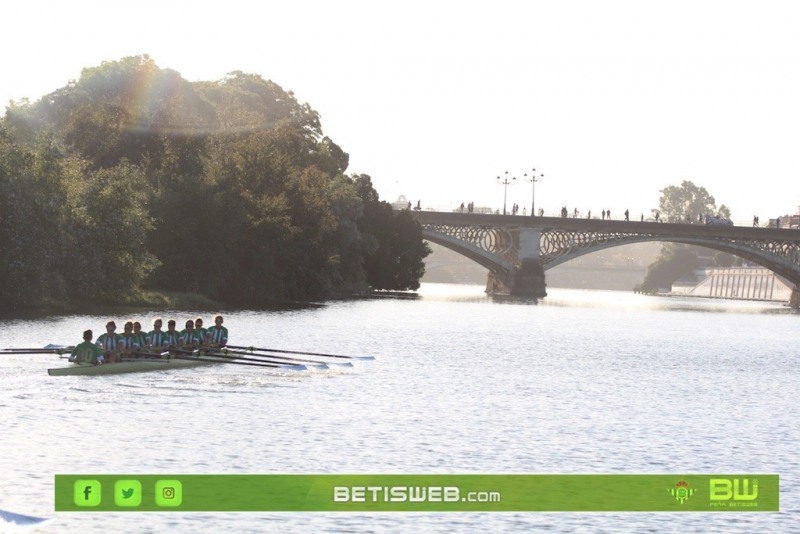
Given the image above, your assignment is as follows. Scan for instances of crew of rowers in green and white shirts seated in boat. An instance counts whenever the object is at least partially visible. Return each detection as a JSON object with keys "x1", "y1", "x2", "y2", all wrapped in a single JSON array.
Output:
[{"x1": 70, "y1": 315, "x2": 228, "y2": 364}]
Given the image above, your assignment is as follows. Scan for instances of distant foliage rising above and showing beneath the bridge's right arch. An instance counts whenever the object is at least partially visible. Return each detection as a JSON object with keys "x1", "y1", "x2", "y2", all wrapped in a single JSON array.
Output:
[{"x1": 637, "y1": 180, "x2": 734, "y2": 293}]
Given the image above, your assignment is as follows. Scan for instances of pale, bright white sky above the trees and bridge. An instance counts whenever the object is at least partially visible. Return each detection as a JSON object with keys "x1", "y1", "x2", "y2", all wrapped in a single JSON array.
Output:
[{"x1": 0, "y1": 0, "x2": 800, "y2": 224}]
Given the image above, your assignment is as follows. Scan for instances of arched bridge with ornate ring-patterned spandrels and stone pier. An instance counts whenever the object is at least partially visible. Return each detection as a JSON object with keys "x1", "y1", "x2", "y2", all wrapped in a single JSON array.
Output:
[{"x1": 412, "y1": 211, "x2": 800, "y2": 307}]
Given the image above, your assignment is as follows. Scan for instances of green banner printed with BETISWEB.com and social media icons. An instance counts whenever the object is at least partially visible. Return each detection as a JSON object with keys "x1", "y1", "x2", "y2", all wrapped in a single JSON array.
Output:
[{"x1": 55, "y1": 473, "x2": 780, "y2": 512}]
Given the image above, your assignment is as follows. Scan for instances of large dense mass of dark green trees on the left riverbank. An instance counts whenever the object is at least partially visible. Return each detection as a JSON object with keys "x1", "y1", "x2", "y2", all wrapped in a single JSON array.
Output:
[{"x1": 0, "y1": 56, "x2": 429, "y2": 309}]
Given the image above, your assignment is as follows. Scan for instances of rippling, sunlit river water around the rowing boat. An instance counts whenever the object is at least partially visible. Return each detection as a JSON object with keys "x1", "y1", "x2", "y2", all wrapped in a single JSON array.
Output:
[{"x1": 0, "y1": 284, "x2": 800, "y2": 533}]
